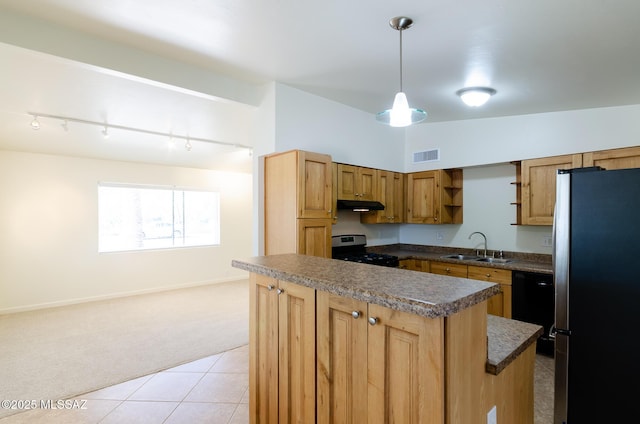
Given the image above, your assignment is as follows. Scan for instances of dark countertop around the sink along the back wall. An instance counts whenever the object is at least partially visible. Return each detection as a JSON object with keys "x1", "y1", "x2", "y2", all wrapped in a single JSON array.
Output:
[{"x1": 367, "y1": 244, "x2": 553, "y2": 274}]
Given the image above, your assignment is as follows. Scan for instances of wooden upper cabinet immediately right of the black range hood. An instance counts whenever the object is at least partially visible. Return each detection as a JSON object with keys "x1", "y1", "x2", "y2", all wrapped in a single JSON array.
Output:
[{"x1": 360, "y1": 170, "x2": 404, "y2": 224}]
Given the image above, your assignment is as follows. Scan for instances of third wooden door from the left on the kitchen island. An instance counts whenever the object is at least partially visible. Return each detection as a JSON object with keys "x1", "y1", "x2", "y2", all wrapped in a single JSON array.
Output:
[{"x1": 317, "y1": 292, "x2": 368, "y2": 424}]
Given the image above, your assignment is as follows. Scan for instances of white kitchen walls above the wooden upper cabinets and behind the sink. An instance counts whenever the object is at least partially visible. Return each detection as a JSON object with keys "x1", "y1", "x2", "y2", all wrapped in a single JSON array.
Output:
[{"x1": 262, "y1": 84, "x2": 640, "y2": 254}]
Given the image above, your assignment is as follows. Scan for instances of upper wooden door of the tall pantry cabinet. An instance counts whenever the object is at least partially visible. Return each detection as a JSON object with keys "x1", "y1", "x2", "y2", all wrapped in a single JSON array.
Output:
[{"x1": 298, "y1": 151, "x2": 333, "y2": 218}]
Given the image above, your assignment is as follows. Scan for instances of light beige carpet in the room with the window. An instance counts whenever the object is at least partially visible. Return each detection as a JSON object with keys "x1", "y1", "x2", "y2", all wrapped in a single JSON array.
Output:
[{"x1": 0, "y1": 280, "x2": 249, "y2": 417}]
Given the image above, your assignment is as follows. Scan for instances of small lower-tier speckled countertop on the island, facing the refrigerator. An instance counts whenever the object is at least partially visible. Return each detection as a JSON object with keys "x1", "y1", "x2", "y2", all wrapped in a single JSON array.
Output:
[{"x1": 486, "y1": 315, "x2": 544, "y2": 375}]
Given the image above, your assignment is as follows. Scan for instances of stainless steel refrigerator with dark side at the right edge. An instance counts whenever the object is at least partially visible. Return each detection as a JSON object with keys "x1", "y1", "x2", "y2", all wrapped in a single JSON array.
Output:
[{"x1": 552, "y1": 168, "x2": 640, "y2": 424}]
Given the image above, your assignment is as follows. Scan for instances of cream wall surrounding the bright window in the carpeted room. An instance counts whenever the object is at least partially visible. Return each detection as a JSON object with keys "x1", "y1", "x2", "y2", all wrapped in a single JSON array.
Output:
[{"x1": 0, "y1": 150, "x2": 253, "y2": 313}]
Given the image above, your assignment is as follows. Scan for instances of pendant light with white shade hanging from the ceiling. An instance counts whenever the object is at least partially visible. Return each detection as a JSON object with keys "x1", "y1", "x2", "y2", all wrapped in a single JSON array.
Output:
[{"x1": 376, "y1": 16, "x2": 427, "y2": 127}]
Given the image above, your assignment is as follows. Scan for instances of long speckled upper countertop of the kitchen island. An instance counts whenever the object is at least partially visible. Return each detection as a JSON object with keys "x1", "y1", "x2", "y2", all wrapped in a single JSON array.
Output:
[{"x1": 231, "y1": 254, "x2": 500, "y2": 318}]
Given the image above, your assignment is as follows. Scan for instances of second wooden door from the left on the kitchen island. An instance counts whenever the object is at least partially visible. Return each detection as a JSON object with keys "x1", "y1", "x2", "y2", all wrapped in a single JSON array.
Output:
[{"x1": 278, "y1": 281, "x2": 316, "y2": 424}]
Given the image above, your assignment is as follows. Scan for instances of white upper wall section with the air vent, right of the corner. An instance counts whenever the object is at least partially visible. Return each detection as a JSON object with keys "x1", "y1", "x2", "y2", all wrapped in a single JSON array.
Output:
[{"x1": 403, "y1": 105, "x2": 640, "y2": 172}]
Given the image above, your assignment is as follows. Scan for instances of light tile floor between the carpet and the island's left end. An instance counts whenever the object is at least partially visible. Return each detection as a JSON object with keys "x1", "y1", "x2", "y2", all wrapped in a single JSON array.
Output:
[{"x1": 0, "y1": 346, "x2": 249, "y2": 424}]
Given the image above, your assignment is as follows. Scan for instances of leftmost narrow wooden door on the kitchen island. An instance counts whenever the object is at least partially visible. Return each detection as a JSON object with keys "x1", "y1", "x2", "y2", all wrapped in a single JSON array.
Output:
[{"x1": 249, "y1": 273, "x2": 279, "y2": 424}]
